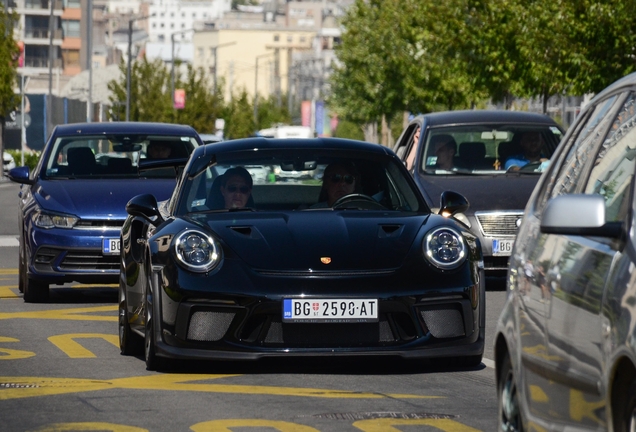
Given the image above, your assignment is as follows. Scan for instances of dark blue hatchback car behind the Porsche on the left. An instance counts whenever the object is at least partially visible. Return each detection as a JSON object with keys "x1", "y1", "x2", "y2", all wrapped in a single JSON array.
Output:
[{"x1": 9, "y1": 122, "x2": 201, "y2": 303}]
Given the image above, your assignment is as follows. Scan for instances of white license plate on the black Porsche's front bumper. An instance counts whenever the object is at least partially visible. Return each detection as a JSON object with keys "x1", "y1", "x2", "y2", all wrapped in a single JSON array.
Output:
[{"x1": 283, "y1": 299, "x2": 378, "y2": 323}]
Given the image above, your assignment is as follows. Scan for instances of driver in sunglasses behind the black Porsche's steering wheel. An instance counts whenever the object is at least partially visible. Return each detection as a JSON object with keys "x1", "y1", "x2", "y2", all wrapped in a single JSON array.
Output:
[{"x1": 311, "y1": 162, "x2": 361, "y2": 208}]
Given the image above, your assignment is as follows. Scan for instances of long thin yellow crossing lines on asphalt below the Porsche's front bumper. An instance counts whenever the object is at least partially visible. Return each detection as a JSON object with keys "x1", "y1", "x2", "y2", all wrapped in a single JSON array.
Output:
[{"x1": 0, "y1": 374, "x2": 444, "y2": 401}]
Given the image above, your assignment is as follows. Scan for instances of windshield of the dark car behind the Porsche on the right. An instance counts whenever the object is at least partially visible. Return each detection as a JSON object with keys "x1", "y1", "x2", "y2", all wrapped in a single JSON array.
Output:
[{"x1": 419, "y1": 124, "x2": 562, "y2": 175}]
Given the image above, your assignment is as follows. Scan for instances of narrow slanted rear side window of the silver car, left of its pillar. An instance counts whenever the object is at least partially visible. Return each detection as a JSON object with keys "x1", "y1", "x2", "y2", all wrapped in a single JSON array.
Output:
[{"x1": 537, "y1": 95, "x2": 624, "y2": 209}]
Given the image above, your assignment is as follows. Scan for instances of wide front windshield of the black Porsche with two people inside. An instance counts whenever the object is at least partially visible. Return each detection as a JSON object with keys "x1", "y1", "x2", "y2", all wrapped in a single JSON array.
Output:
[{"x1": 178, "y1": 149, "x2": 426, "y2": 214}]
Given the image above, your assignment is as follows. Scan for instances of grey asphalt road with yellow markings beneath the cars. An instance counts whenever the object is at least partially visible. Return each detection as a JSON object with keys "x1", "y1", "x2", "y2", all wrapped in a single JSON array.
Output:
[{"x1": 0, "y1": 177, "x2": 505, "y2": 432}]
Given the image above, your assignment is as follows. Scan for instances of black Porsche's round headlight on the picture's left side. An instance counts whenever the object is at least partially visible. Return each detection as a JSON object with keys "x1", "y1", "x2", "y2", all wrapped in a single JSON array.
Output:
[{"x1": 174, "y1": 230, "x2": 222, "y2": 273}]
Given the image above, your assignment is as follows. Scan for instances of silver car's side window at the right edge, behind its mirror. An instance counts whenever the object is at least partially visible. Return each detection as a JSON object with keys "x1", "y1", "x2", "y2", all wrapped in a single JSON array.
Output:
[{"x1": 585, "y1": 93, "x2": 636, "y2": 222}]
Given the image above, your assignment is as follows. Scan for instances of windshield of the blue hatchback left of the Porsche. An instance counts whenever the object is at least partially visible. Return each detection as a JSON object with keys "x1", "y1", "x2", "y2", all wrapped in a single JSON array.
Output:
[{"x1": 43, "y1": 134, "x2": 198, "y2": 179}]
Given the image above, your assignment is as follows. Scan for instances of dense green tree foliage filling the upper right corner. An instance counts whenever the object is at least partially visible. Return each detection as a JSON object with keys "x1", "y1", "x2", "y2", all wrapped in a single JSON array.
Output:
[{"x1": 328, "y1": 0, "x2": 636, "y2": 125}]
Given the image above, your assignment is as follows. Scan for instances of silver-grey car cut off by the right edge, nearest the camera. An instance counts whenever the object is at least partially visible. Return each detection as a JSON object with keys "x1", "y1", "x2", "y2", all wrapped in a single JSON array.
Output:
[{"x1": 494, "y1": 74, "x2": 636, "y2": 432}]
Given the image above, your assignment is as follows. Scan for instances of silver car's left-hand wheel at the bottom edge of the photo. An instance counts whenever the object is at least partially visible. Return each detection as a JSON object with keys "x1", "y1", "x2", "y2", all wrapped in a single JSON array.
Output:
[{"x1": 497, "y1": 355, "x2": 523, "y2": 432}]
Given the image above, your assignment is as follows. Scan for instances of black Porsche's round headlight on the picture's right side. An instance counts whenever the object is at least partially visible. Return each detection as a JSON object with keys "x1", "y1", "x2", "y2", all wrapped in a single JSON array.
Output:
[{"x1": 422, "y1": 227, "x2": 467, "y2": 270}]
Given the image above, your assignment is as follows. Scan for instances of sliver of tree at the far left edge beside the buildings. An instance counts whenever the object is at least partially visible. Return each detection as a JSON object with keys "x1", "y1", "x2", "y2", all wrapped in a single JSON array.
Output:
[{"x1": 0, "y1": 6, "x2": 21, "y2": 176}]
